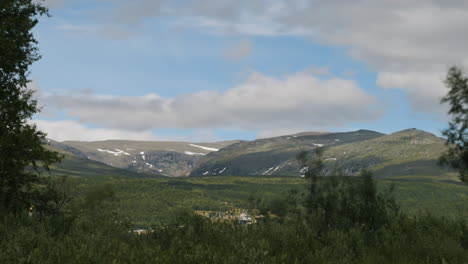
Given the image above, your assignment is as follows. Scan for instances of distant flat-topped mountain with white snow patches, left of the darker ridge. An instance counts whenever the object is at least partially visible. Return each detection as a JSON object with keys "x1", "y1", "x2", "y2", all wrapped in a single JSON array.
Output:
[{"x1": 50, "y1": 140, "x2": 238, "y2": 176}]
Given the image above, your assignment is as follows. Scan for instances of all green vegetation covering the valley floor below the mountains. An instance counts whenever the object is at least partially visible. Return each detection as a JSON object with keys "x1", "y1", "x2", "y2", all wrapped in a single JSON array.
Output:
[{"x1": 4, "y1": 166, "x2": 468, "y2": 263}]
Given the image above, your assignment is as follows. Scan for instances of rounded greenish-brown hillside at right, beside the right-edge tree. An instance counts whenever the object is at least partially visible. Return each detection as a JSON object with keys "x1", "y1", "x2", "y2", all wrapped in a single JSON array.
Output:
[{"x1": 325, "y1": 129, "x2": 446, "y2": 177}]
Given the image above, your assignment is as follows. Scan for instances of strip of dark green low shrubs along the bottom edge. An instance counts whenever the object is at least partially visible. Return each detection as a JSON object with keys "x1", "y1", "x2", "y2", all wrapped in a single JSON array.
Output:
[{"x1": 0, "y1": 202, "x2": 468, "y2": 263}]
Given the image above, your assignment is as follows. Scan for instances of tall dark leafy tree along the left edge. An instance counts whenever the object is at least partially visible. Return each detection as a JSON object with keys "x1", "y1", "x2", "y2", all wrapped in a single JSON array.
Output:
[{"x1": 0, "y1": 0, "x2": 60, "y2": 213}]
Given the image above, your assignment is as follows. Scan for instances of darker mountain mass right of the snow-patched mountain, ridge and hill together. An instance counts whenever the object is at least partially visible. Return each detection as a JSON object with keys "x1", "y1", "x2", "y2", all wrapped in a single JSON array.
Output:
[{"x1": 191, "y1": 129, "x2": 446, "y2": 177}]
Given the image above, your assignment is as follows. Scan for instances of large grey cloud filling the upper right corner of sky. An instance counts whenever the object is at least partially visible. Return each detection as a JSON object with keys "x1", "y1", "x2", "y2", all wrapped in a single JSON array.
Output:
[{"x1": 175, "y1": 0, "x2": 468, "y2": 112}]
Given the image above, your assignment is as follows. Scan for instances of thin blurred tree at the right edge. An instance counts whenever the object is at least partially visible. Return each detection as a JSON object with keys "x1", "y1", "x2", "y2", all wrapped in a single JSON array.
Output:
[{"x1": 439, "y1": 66, "x2": 468, "y2": 182}]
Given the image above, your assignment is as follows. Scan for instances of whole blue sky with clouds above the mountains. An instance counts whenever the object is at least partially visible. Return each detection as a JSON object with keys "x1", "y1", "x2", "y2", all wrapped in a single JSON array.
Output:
[{"x1": 30, "y1": 0, "x2": 468, "y2": 142}]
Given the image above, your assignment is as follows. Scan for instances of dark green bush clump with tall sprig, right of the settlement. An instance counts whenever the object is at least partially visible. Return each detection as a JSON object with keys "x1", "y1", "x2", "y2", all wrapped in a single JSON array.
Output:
[{"x1": 298, "y1": 148, "x2": 399, "y2": 234}]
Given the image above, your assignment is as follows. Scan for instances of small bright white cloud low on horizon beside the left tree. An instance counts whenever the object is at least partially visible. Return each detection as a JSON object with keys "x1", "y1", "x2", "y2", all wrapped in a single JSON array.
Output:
[{"x1": 33, "y1": 120, "x2": 157, "y2": 141}]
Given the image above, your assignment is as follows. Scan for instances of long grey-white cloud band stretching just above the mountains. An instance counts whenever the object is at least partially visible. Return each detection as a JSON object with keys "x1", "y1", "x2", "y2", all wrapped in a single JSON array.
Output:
[{"x1": 39, "y1": 72, "x2": 382, "y2": 131}]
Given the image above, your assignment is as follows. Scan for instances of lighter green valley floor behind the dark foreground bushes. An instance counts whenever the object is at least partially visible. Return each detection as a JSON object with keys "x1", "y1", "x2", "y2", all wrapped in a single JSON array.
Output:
[{"x1": 59, "y1": 172, "x2": 468, "y2": 226}]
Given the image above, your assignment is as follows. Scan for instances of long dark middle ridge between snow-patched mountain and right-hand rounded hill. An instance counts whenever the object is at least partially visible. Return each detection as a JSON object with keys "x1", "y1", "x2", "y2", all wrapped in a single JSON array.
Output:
[{"x1": 191, "y1": 130, "x2": 384, "y2": 176}]
